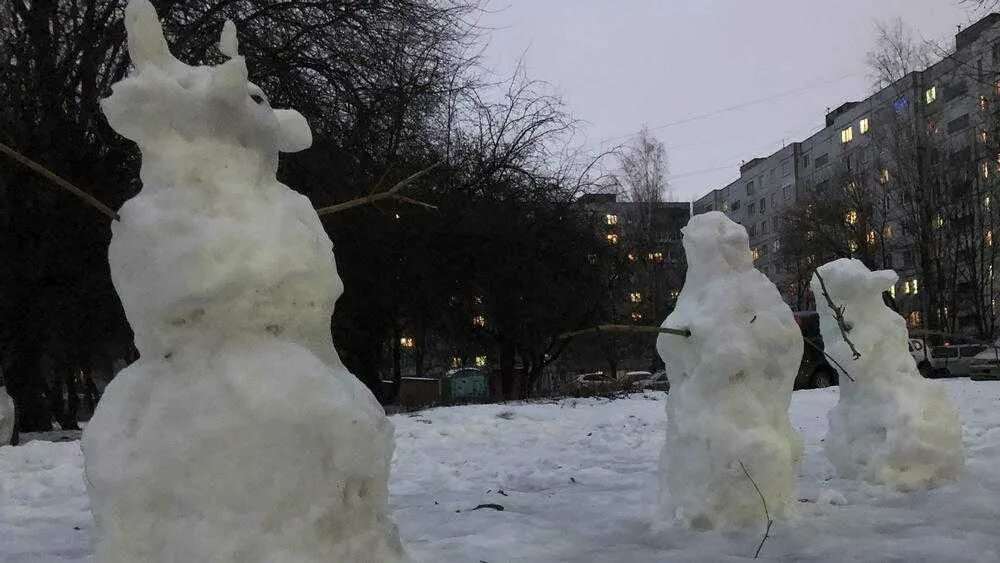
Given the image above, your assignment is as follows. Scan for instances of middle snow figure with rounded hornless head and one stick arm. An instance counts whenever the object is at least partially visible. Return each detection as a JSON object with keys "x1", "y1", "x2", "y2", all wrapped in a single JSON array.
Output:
[{"x1": 657, "y1": 212, "x2": 803, "y2": 530}]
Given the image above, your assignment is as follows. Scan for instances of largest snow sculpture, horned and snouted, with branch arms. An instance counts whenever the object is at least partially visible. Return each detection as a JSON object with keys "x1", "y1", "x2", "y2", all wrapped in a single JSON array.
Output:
[{"x1": 83, "y1": 0, "x2": 405, "y2": 563}]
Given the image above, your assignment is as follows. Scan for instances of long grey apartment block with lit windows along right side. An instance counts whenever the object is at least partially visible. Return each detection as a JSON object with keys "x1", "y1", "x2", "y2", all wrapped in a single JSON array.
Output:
[{"x1": 694, "y1": 14, "x2": 1000, "y2": 340}]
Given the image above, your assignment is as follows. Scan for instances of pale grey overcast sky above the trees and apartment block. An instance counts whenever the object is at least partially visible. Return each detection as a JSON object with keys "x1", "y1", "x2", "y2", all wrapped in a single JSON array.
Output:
[{"x1": 481, "y1": 0, "x2": 977, "y2": 200}]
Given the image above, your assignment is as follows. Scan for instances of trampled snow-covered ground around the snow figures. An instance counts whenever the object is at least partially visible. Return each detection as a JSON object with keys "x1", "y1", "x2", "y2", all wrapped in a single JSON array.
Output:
[{"x1": 0, "y1": 379, "x2": 1000, "y2": 563}]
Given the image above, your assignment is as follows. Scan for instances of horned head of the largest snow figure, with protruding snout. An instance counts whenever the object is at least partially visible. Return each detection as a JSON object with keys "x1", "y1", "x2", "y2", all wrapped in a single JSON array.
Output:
[{"x1": 101, "y1": 0, "x2": 312, "y2": 180}]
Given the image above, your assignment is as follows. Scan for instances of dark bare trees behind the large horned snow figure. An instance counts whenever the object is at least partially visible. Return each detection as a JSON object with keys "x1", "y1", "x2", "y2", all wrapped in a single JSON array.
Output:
[{"x1": 0, "y1": 0, "x2": 604, "y2": 431}]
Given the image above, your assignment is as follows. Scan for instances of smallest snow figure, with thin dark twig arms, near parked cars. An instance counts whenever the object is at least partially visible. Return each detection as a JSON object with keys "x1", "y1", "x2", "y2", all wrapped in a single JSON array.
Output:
[{"x1": 810, "y1": 258, "x2": 965, "y2": 490}]
